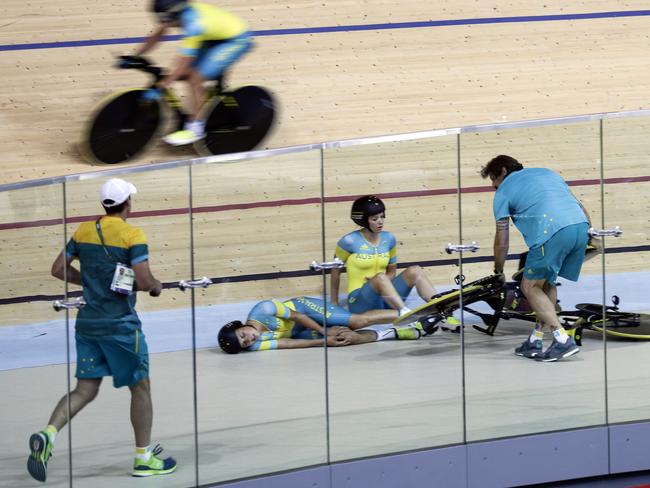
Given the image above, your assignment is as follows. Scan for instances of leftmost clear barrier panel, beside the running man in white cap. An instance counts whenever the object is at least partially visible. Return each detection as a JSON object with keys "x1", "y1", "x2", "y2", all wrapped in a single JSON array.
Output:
[{"x1": 0, "y1": 184, "x2": 74, "y2": 487}]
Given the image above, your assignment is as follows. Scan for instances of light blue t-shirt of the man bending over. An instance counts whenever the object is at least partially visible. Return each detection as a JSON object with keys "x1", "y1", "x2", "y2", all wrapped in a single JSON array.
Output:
[{"x1": 493, "y1": 168, "x2": 588, "y2": 248}]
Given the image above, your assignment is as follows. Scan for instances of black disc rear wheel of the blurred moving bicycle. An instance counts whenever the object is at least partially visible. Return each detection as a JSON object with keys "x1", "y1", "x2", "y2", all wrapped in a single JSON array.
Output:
[{"x1": 194, "y1": 86, "x2": 275, "y2": 156}]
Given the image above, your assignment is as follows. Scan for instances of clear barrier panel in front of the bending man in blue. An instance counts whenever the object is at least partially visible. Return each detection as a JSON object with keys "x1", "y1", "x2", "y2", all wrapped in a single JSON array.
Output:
[{"x1": 460, "y1": 121, "x2": 605, "y2": 441}]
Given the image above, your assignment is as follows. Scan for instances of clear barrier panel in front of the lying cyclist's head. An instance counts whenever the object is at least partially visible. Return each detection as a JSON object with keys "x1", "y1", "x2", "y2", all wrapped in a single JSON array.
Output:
[{"x1": 192, "y1": 151, "x2": 327, "y2": 485}]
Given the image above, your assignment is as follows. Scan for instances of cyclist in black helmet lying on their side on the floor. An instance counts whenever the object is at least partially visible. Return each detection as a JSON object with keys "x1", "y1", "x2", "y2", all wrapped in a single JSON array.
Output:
[{"x1": 219, "y1": 296, "x2": 422, "y2": 354}]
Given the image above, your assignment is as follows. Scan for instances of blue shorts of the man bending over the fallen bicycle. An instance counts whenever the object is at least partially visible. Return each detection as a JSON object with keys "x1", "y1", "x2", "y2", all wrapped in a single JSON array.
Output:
[{"x1": 524, "y1": 222, "x2": 589, "y2": 285}]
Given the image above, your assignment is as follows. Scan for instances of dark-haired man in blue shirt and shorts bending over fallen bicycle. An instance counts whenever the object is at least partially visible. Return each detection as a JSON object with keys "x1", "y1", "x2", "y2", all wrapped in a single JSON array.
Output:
[{"x1": 481, "y1": 155, "x2": 591, "y2": 361}]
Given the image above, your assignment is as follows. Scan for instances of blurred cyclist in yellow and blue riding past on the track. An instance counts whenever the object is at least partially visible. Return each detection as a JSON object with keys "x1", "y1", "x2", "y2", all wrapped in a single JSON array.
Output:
[{"x1": 125, "y1": 0, "x2": 253, "y2": 146}]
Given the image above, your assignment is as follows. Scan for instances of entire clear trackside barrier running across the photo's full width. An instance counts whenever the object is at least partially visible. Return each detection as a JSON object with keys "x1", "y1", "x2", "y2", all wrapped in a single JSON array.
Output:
[{"x1": 0, "y1": 108, "x2": 650, "y2": 487}]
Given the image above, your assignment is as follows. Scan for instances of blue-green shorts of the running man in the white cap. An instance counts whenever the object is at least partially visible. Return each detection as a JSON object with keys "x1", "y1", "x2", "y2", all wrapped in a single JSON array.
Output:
[{"x1": 75, "y1": 331, "x2": 149, "y2": 388}]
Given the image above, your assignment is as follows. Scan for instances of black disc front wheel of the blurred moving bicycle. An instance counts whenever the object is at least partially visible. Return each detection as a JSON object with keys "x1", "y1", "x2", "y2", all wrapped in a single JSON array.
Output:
[{"x1": 81, "y1": 89, "x2": 164, "y2": 164}]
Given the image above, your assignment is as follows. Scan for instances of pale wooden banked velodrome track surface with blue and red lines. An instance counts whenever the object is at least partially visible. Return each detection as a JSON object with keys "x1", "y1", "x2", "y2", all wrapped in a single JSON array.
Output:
[{"x1": 0, "y1": 0, "x2": 650, "y2": 325}]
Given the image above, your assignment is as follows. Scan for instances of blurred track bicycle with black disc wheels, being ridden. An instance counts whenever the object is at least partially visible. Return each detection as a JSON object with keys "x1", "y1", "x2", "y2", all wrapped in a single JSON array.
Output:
[{"x1": 81, "y1": 56, "x2": 275, "y2": 164}]
